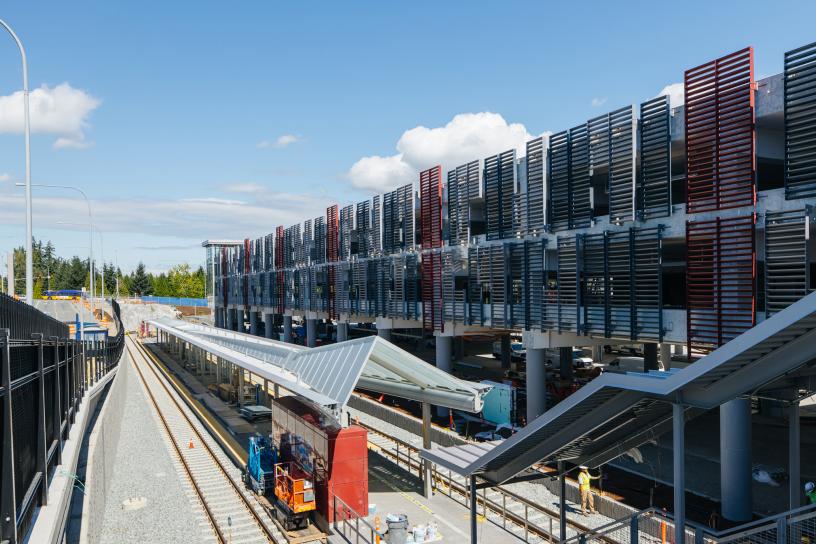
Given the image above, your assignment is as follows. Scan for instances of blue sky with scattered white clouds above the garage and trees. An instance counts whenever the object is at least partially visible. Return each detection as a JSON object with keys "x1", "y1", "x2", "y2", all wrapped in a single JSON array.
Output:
[{"x1": 0, "y1": 0, "x2": 816, "y2": 270}]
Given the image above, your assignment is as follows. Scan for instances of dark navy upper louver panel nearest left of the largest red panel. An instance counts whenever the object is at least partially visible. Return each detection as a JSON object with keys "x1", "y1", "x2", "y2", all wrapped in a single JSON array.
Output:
[{"x1": 638, "y1": 96, "x2": 671, "y2": 220}]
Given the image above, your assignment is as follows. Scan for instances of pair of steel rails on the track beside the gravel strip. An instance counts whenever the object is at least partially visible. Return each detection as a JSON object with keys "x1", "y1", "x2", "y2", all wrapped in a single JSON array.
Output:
[{"x1": 128, "y1": 339, "x2": 279, "y2": 544}]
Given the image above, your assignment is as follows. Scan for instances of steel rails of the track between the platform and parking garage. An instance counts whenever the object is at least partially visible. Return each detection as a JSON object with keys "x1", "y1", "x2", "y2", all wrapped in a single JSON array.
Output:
[{"x1": 355, "y1": 422, "x2": 619, "y2": 544}]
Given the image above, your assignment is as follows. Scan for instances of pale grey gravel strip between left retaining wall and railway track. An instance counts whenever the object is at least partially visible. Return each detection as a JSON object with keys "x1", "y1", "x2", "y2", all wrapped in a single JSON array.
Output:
[{"x1": 99, "y1": 353, "x2": 211, "y2": 544}]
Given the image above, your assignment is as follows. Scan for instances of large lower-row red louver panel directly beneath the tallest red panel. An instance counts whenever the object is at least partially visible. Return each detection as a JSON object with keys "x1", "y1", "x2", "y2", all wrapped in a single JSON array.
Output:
[{"x1": 686, "y1": 213, "x2": 756, "y2": 357}]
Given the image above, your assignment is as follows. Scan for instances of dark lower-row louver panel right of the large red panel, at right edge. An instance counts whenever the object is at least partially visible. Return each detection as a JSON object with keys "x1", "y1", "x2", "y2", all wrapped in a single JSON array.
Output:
[{"x1": 765, "y1": 208, "x2": 812, "y2": 315}]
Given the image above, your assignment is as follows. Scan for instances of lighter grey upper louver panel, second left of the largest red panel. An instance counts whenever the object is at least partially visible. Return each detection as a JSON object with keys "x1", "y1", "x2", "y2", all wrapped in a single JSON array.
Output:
[{"x1": 609, "y1": 106, "x2": 637, "y2": 225}]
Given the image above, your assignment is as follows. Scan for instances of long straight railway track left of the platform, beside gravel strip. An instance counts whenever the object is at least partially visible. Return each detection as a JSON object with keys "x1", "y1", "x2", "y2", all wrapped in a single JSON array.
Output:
[{"x1": 126, "y1": 337, "x2": 288, "y2": 544}]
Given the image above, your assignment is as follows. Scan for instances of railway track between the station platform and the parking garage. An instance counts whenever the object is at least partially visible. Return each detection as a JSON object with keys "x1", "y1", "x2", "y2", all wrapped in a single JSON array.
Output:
[{"x1": 356, "y1": 422, "x2": 619, "y2": 544}]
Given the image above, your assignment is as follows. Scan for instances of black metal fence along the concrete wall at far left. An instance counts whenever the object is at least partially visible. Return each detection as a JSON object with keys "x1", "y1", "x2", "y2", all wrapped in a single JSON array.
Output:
[{"x1": 0, "y1": 295, "x2": 124, "y2": 544}]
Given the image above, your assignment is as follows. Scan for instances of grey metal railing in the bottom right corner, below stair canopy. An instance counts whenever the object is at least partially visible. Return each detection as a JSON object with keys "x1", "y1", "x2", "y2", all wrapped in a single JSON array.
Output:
[{"x1": 564, "y1": 504, "x2": 816, "y2": 544}]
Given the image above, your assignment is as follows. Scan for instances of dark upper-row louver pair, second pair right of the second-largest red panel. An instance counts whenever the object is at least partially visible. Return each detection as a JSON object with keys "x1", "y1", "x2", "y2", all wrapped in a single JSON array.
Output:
[{"x1": 484, "y1": 149, "x2": 516, "y2": 240}]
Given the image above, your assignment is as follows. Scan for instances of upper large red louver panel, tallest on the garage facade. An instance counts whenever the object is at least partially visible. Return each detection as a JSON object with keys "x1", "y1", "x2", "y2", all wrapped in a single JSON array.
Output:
[{"x1": 685, "y1": 47, "x2": 756, "y2": 213}]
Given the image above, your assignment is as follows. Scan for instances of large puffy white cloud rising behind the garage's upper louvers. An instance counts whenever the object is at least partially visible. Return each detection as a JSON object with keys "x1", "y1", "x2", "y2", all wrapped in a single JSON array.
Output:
[{"x1": 348, "y1": 112, "x2": 534, "y2": 192}]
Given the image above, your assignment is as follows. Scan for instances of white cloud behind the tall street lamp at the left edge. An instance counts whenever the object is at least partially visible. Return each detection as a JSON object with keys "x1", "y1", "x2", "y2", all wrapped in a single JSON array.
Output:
[{"x1": 0, "y1": 83, "x2": 101, "y2": 149}]
